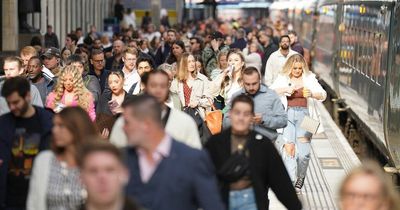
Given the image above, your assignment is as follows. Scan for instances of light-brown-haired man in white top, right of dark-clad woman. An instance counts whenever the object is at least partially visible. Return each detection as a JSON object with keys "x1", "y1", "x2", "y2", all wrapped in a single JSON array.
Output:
[{"x1": 122, "y1": 48, "x2": 141, "y2": 95}]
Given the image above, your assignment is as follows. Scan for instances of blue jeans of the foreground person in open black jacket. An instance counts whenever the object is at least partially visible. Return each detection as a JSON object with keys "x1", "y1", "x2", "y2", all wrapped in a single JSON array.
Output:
[{"x1": 229, "y1": 188, "x2": 257, "y2": 210}]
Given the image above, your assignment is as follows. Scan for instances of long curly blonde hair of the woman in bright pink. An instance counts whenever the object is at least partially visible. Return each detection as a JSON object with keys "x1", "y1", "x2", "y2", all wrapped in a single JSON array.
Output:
[{"x1": 52, "y1": 65, "x2": 91, "y2": 111}]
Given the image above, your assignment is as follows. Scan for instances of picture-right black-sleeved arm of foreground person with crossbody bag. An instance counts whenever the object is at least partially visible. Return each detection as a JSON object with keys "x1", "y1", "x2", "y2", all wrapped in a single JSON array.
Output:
[{"x1": 264, "y1": 142, "x2": 302, "y2": 210}]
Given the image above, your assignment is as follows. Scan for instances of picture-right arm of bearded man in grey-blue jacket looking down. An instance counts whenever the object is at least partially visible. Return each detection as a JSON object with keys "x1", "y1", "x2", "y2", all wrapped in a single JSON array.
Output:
[{"x1": 262, "y1": 93, "x2": 288, "y2": 129}]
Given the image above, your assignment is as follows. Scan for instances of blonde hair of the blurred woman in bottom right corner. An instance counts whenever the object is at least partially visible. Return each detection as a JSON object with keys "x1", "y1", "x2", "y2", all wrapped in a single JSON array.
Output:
[{"x1": 339, "y1": 161, "x2": 400, "y2": 210}]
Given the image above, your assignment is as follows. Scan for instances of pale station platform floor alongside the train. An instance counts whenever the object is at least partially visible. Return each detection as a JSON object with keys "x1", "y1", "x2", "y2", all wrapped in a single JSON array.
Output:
[{"x1": 268, "y1": 103, "x2": 360, "y2": 210}]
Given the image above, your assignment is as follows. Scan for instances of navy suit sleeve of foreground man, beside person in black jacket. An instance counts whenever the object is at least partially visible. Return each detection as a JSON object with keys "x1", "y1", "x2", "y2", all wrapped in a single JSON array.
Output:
[{"x1": 191, "y1": 150, "x2": 226, "y2": 210}]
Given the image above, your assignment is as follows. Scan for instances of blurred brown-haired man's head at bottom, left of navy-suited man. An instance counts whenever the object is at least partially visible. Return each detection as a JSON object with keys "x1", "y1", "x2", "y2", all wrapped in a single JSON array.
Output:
[{"x1": 77, "y1": 139, "x2": 139, "y2": 210}]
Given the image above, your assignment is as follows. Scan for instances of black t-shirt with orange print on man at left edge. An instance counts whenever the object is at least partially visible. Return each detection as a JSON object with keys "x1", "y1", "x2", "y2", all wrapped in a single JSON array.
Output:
[{"x1": 6, "y1": 114, "x2": 42, "y2": 207}]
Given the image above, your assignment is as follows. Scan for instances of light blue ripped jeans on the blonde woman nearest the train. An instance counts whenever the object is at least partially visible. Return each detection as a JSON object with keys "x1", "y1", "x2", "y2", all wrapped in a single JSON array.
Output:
[{"x1": 282, "y1": 107, "x2": 312, "y2": 182}]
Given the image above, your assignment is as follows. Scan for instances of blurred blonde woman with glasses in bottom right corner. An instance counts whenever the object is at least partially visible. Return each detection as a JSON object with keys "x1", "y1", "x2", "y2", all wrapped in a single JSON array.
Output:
[{"x1": 339, "y1": 161, "x2": 400, "y2": 210}]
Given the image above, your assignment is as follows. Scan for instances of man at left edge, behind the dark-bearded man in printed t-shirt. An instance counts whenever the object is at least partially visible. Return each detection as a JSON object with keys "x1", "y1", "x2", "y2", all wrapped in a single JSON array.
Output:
[{"x1": 0, "y1": 56, "x2": 43, "y2": 115}]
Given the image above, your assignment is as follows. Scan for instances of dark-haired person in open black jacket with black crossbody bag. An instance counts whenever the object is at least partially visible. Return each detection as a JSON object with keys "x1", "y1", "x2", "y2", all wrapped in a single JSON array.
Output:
[{"x1": 205, "y1": 95, "x2": 301, "y2": 210}]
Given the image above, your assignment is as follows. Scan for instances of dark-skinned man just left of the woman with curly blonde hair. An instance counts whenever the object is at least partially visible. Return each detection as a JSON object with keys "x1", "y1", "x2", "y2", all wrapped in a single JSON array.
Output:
[{"x1": 27, "y1": 56, "x2": 55, "y2": 102}]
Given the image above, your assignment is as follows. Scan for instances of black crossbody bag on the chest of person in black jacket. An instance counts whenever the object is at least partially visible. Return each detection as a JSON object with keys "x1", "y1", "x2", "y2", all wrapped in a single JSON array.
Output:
[{"x1": 217, "y1": 142, "x2": 250, "y2": 182}]
